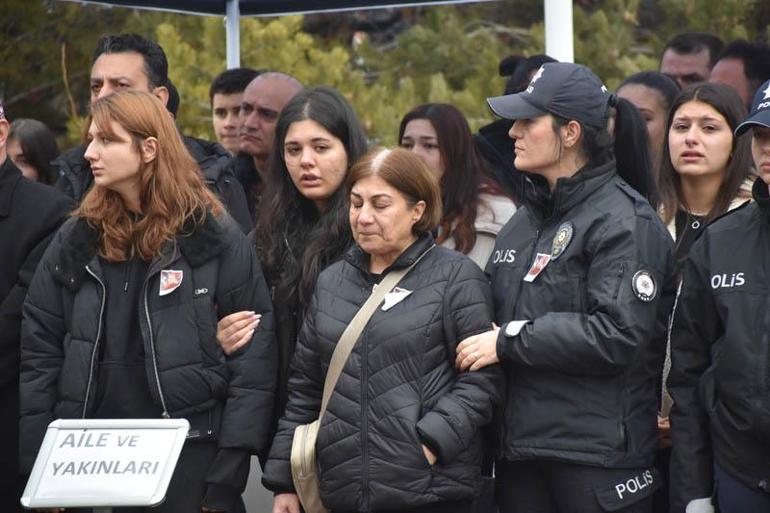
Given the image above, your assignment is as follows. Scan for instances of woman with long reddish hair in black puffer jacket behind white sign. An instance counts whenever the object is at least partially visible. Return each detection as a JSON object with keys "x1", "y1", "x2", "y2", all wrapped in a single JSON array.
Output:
[{"x1": 20, "y1": 91, "x2": 277, "y2": 511}]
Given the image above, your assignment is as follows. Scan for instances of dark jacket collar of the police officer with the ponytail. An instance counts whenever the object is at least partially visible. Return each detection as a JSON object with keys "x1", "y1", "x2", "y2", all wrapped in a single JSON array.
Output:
[{"x1": 532, "y1": 160, "x2": 616, "y2": 221}]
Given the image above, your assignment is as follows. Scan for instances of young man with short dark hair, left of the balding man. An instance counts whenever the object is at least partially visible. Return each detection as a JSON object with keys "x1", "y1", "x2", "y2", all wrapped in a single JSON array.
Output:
[{"x1": 209, "y1": 68, "x2": 260, "y2": 155}]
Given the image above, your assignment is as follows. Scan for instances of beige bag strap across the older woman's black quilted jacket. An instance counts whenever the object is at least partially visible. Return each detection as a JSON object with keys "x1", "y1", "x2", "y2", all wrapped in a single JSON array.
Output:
[{"x1": 318, "y1": 244, "x2": 436, "y2": 420}]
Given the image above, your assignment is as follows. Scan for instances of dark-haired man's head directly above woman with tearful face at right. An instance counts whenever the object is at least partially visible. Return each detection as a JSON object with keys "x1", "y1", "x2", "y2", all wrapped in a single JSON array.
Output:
[{"x1": 660, "y1": 32, "x2": 724, "y2": 89}]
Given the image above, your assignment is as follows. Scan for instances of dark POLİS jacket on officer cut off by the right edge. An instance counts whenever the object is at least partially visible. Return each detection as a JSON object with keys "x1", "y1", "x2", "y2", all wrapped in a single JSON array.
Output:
[{"x1": 668, "y1": 178, "x2": 770, "y2": 511}]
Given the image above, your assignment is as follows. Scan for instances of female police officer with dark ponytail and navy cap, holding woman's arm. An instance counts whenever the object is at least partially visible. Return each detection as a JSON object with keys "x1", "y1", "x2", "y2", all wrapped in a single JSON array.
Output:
[{"x1": 457, "y1": 63, "x2": 672, "y2": 513}]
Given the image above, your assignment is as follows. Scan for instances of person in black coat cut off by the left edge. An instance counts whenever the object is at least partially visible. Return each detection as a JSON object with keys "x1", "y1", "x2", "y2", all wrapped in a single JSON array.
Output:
[{"x1": 0, "y1": 104, "x2": 74, "y2": 511}]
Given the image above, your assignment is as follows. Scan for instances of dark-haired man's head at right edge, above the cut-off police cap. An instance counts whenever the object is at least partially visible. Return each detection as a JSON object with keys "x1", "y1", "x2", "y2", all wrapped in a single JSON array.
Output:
[{"x1": 709, "y1": 39, "x2": 770, "y2": 112}]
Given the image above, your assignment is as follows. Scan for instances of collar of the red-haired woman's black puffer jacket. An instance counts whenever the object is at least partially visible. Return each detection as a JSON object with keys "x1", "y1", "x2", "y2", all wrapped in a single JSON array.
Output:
[{"x1": 54, "y1": 210, "x2": 227, "y2": 291}]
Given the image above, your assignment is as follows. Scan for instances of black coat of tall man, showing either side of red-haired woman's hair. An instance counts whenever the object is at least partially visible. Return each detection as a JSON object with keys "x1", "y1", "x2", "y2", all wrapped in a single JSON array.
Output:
[{"x1": 52, "y1": 136, "x2": 254, "y2": 233}]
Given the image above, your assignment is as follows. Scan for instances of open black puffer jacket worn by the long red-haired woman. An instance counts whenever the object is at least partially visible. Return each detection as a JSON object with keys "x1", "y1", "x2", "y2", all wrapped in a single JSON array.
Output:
[{"x1": 20, "y1": 215, "x2": 277, "y2": 471}]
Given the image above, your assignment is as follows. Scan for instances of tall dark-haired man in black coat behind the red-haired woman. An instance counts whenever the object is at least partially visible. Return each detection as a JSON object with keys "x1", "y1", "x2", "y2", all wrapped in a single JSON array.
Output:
[{"x1": 54, "y1": 34, "x2": 253, "y2": 233}]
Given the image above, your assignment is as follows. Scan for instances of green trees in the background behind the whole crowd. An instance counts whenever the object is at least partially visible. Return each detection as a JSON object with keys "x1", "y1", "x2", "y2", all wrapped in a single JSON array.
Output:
[{"x1": 0, "y1": 0, "x2": 770, "y2": 150}]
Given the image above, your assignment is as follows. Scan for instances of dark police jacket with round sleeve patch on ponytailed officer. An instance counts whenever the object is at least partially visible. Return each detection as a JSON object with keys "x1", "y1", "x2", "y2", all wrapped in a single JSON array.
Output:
[{"x1": 487, "y1": 162, "x2": 674, "y2": 468}]
